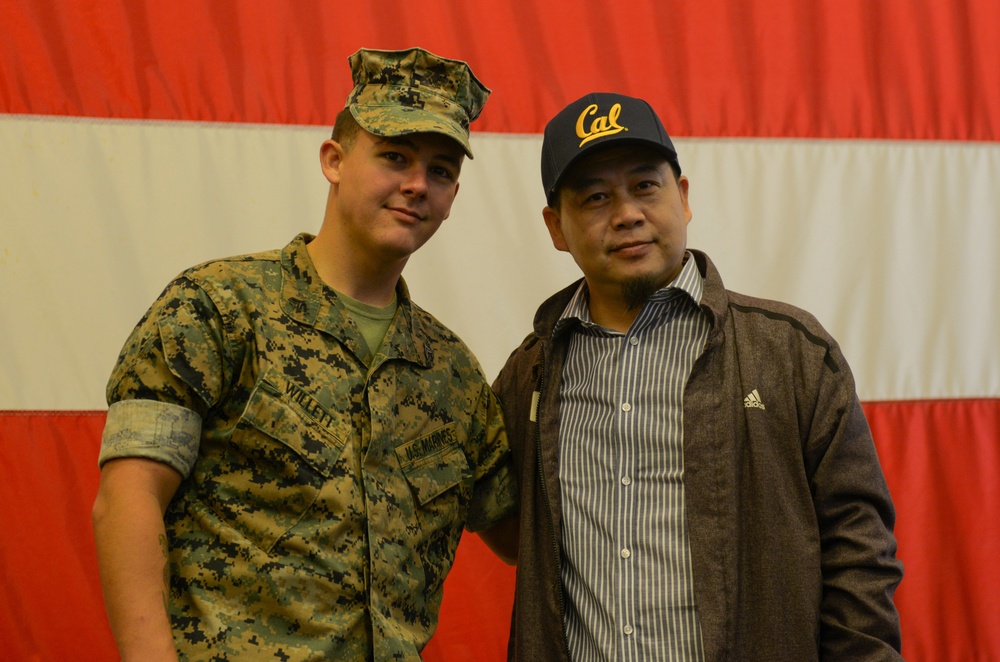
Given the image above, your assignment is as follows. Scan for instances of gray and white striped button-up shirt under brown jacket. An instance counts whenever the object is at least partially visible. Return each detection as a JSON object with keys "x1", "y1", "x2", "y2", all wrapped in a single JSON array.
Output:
[{"x1": 554, "y1": 253, "x2": 709, "y2": 661}]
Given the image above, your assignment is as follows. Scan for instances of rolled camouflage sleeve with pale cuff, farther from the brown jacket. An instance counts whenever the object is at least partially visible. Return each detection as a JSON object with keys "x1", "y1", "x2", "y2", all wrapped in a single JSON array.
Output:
[{"x1": 98, "y1": 277, "x2": 226, "y2": 477}]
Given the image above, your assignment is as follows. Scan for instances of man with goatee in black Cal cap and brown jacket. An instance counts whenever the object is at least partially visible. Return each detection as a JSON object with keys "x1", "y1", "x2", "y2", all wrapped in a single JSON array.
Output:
[{"x1": 494, "y1": 93, "x2": 902, "y2": 662}]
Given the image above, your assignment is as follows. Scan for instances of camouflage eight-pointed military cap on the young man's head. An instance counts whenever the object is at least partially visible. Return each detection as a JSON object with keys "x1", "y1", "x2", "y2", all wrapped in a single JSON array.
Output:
[{"x1": 345, "y1": 48, "x2": 490, "y2": 159}]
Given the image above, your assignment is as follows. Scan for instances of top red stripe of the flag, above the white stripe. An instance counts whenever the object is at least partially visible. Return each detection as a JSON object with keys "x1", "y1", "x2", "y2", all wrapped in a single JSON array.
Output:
[{"x1": 0, "y1": 0, "x2": 1000, "y2": 141}]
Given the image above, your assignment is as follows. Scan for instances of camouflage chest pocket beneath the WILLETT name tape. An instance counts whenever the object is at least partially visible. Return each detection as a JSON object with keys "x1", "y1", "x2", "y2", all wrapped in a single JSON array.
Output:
[{"x1": 204, "y1": 377, "x2": 344, "y2": 550}]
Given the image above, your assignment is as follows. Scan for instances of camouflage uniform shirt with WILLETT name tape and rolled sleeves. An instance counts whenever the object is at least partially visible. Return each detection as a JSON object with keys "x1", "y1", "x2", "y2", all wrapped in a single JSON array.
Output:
[{"x1": 100, "y1": 235, "x2": 515, "y2": 660}]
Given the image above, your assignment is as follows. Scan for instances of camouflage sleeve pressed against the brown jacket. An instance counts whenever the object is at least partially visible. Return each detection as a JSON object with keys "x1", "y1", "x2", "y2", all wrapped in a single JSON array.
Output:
[{"x1": 466, "y1": 384, "x2": 517, "y2": 531}]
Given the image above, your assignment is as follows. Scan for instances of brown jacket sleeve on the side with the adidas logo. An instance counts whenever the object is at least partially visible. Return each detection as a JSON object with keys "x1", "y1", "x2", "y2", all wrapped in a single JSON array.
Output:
[{"x1": 805, "y1": 344, "x2": 903, "y2": 660}]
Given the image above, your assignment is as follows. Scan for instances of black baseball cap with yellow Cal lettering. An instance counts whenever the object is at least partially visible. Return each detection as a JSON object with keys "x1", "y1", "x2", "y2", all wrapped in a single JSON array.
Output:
[{"x1": 542, "y1": 92, "x2": 680, "y2": 204}]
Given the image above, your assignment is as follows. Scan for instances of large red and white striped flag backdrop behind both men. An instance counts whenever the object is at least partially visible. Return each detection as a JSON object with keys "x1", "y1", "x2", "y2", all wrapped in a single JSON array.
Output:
[{"x1": 0, "y1": 0, "x2": 1000, "y2": 661}]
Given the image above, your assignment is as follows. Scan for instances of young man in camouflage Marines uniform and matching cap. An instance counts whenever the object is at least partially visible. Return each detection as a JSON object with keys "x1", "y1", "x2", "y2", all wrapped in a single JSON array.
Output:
[{"x1": 94, "y1": 48, "x2": 516, "y2": 660}]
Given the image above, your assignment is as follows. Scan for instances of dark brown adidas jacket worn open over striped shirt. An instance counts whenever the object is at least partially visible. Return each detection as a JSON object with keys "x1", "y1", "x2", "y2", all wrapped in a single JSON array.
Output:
[{"x1": 494, "y1": 251, "x2": 903, "y2": 662}]
